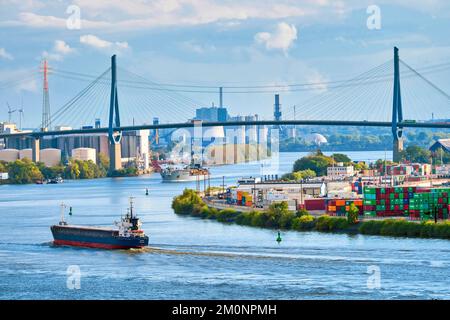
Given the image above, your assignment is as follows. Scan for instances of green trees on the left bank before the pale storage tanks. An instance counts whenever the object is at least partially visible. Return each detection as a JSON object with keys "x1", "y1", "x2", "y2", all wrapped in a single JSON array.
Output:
[{"x1": 0, "y1": 154, "x2": 138, "y2": 184}]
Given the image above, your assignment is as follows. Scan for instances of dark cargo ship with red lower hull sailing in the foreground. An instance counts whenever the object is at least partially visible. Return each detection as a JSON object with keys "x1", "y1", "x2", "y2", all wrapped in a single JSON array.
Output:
[{"x1": 50, "y1": 198, "x2": 148, "y2": 249}]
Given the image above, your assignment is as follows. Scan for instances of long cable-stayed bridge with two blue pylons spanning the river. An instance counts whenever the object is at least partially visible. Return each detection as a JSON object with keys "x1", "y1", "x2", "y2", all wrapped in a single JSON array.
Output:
[{"x1": 0, "y1": 48, "x2": 450, "y2": 169}]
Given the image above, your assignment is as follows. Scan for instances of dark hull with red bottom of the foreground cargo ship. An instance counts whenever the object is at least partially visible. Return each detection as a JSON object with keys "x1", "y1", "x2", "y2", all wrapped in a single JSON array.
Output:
[{"x1": 50, "y1": 225, "x2": 148, "y2": 249}]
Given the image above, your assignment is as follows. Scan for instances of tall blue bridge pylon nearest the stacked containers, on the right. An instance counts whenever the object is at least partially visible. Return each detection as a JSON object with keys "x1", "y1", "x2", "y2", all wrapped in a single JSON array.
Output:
[{"x1": 392, "y1": 47, "x2": 403, "y2": 162}]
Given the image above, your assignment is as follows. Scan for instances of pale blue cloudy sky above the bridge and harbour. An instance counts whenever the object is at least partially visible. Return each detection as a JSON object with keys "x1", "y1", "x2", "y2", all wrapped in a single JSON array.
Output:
[{"x1": 0, "y1": 0, "x2": 450, "y2": 127}]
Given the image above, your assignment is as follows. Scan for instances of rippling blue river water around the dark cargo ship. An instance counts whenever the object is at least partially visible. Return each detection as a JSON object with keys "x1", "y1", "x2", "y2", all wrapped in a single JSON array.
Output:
[{"x1": 0, "y1": 151, "x2": 450, "y2": 299}]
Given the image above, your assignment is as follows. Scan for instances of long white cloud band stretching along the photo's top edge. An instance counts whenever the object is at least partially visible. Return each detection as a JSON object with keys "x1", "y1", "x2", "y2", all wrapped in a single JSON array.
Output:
[{"x1": 0, "y1": 0, "x2": 450, "y2": 30}]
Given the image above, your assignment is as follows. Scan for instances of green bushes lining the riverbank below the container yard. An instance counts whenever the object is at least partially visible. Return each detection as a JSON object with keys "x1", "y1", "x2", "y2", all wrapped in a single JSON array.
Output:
[{"x1": 172, "y1": 189, "x2": 450, "y2": 239}]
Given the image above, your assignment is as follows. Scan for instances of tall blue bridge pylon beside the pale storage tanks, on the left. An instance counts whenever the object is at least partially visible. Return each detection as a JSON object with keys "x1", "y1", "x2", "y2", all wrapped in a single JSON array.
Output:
[{"x1": 108, "y1": 55, "x2": 122, "y2": 172}]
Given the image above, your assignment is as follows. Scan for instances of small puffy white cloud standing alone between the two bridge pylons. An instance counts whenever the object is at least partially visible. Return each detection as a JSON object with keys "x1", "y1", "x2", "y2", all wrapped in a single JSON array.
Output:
[{"x1": 255, "y1": 22, "x2": 297, "y2": 53}]
